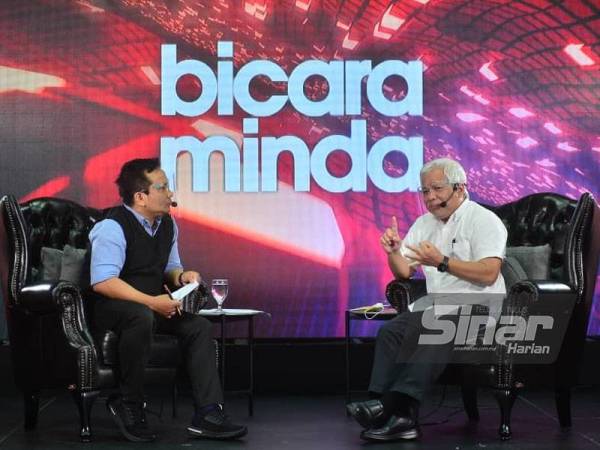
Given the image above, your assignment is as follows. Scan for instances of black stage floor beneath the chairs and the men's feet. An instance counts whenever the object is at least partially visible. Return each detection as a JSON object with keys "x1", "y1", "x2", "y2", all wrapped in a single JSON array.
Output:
[{"x1": 0, "y1": 386, "x2": 600, "y2": 450}]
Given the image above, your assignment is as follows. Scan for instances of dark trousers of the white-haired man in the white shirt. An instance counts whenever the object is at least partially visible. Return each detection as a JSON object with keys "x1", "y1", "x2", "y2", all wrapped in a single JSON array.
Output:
[{"x1": 369, "y1": 311, "x2": 452, "y2": 401}]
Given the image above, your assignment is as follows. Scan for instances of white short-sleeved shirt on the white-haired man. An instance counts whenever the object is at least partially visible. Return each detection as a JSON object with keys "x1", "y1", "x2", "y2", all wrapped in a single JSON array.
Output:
[{"x1": 400, "y1": 199, "x2": 508, "y2": 294}]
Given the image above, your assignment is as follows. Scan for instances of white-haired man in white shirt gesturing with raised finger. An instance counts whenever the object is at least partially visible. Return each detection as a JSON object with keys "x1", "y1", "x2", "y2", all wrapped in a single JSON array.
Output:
[{"x1": 348, "y1": 158, "x2": 507, "y2": 441}]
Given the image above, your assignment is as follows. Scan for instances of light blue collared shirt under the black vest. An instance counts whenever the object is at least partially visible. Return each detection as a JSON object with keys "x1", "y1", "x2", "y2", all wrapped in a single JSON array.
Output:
[{"x1": 90, "y1": 205, "x2": 183, "y2": 285}]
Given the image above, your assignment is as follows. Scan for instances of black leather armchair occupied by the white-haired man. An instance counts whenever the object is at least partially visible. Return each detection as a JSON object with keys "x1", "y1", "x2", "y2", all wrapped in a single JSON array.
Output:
[{"x1": 386, "y1": 193, "x2": 600, "y2": 440}]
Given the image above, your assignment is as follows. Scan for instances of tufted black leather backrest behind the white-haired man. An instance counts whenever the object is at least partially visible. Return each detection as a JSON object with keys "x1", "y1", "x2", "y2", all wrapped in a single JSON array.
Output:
[{"x1": 484, "y1": 193, "x2": 577, "y2": 282}]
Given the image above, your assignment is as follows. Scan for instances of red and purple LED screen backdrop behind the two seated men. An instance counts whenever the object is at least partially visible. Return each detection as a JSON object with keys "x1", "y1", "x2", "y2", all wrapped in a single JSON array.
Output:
[{"x1": 0, "y1": 0, "x2": 600, "y2": 337}]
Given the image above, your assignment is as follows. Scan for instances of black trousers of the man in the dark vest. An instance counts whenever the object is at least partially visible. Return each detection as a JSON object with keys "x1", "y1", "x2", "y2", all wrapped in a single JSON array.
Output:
[{"x1": 94, "y1": 298, "x2": 223, "y2": 407}]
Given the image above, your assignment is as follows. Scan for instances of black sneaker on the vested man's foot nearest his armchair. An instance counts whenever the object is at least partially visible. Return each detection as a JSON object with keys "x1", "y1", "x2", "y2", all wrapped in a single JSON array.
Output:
[{"x1": 106, "y1": 396, "x2": 156, "y2": 442}]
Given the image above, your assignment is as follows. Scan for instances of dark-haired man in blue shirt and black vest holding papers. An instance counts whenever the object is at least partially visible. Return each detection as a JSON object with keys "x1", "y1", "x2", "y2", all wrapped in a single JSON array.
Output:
[{"x1": 90, "y1": 159, "x2": 247, "y2": 442}]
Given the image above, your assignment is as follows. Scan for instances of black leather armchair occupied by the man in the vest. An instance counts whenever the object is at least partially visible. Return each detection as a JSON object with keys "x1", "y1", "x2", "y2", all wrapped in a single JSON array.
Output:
[{"x1": 0, "y1": 196, "x2": 208, "y2": 442}]
